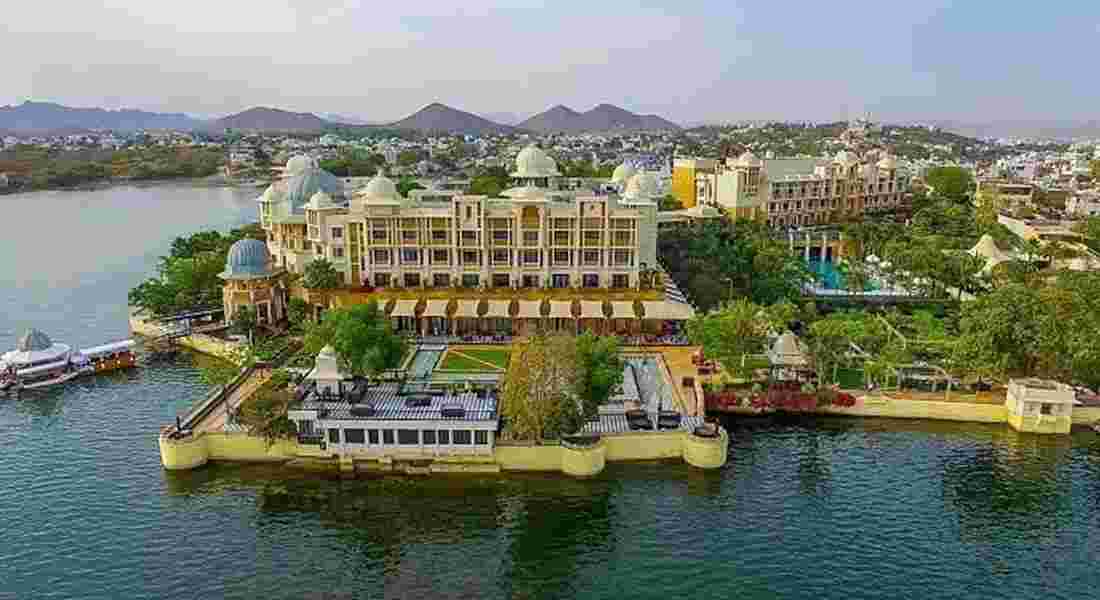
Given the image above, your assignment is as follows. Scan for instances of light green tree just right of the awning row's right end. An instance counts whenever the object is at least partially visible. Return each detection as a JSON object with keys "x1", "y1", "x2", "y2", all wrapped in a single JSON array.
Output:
[{"x1": 688, "y1": 298, "x2": 765, "y2": 379}]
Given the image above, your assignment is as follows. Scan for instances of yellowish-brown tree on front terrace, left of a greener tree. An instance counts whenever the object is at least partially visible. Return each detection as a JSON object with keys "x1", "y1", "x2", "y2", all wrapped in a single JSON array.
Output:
[{"x1": 501, "y1": 332, "x2": 584, "y2": 440}]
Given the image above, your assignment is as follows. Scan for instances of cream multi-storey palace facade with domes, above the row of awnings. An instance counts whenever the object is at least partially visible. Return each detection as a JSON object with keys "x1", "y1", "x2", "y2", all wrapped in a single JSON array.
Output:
[{"x1": 260, "y1": 146, "x2": 657, "y2": 288}]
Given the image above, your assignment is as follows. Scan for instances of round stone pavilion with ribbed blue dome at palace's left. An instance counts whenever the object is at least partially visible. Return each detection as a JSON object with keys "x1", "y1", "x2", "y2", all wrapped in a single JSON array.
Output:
[{"x1": 219, "y1": 239, "x2": 287, "y2": 325}]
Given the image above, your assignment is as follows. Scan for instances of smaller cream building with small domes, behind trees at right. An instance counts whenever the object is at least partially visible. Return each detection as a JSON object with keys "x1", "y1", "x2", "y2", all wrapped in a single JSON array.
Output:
[{"x1": 694, "y1": 152, "x2": 910, "y2": 227}]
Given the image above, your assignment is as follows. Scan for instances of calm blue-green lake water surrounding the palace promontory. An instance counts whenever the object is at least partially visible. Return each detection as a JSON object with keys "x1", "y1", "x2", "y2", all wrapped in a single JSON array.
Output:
[{"x1": 0, "y1": 185, "x2": 1100, "y2": 600}]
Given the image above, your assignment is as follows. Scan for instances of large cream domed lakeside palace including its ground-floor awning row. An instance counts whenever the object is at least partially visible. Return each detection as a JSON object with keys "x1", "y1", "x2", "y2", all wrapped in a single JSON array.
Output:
[{"x1": 251, "y1": 145, "x2": 694, "y2": 337}]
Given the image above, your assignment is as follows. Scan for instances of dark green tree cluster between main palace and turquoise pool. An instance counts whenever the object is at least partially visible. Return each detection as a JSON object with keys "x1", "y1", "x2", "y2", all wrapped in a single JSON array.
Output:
[{"x1": 658, "y1": 217, "x2": 814, "y2": 312}]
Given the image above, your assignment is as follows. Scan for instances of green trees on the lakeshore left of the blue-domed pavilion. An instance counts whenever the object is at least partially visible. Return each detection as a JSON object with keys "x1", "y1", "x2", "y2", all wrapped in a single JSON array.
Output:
[{"x1": 128, "y1": 223, "x2": 264, "y2": 315}]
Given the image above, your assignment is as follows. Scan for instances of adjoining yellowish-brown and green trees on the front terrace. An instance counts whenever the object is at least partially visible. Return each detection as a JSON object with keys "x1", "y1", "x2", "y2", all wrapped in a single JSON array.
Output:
[{"x1": 501, "y1": 332, "x2": 623, "y2": 440}]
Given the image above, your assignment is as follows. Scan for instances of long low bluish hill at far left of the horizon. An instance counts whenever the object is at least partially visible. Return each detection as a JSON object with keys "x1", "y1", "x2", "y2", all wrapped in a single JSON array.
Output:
[{"x1": 0, "y1": 101, "x2": 204, "y2": 133}]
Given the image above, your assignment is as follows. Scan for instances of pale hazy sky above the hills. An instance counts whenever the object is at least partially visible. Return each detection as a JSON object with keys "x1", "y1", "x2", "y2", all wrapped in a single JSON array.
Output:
[{"x1": 0, "y1": 0, "x2": 1100, "y2": 122}]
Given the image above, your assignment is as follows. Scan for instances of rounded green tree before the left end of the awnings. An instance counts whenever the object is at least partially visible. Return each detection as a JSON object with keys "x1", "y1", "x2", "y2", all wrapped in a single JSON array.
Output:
[{"x1": 304, "y1": 299, "x2": 406, "y2": 375}]
